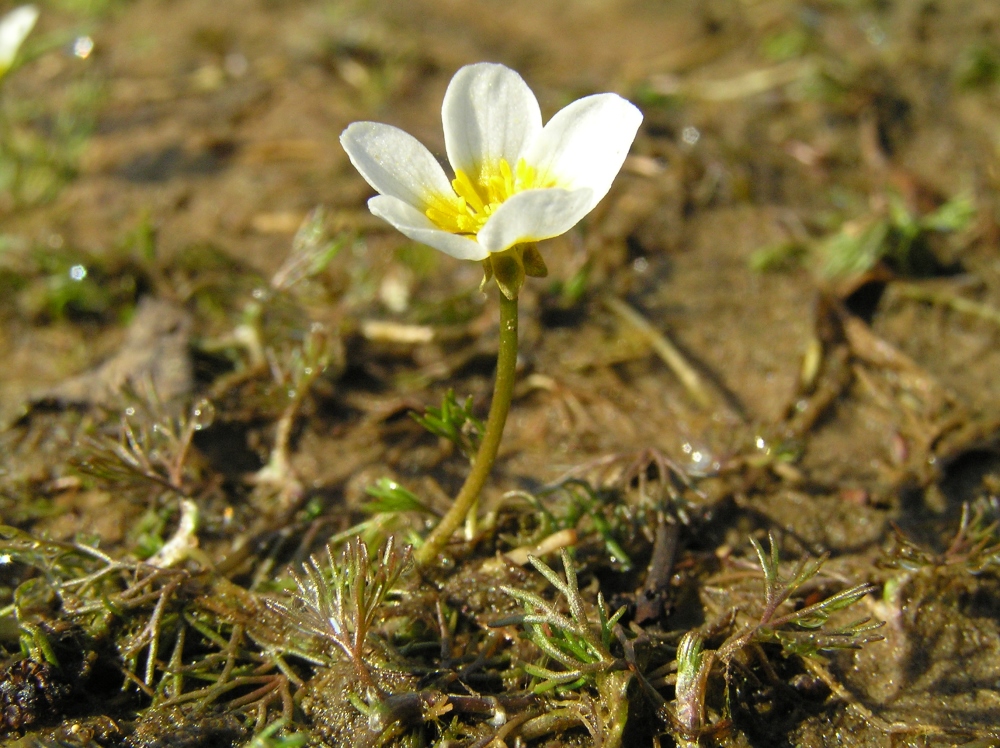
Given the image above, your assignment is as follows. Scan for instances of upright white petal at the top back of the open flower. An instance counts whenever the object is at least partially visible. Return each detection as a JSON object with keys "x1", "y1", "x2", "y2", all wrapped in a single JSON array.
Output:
[{"x1": 441, "y1": 62, "x2": 542, "y2": 179}]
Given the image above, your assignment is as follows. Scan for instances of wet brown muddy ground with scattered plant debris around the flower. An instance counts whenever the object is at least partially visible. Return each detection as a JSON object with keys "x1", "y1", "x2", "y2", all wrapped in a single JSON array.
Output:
[{"x1": 0, "y1": 0, "x2": 1000, "y2": 746}]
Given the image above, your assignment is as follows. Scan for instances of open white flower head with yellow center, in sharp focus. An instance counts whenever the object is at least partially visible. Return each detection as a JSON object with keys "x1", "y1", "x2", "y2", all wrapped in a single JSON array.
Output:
[{"x1": 340, "y1": 63, "x2": 642, "y2": 290}]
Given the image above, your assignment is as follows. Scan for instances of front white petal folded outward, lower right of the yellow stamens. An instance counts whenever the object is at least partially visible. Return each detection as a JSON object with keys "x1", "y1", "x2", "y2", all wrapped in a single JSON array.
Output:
[{"x1": 476, "y1": 187, "x2": 593, "y2": 252}]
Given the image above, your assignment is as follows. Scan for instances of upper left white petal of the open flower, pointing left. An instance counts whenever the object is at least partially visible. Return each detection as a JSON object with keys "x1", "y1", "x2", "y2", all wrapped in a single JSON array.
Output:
[{"x1": 340, "y1": 122, "x2": 455, "y2": 210}]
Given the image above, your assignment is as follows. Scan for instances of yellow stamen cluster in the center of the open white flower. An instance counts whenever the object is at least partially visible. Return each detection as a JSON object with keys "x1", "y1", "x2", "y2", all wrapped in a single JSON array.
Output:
[{"x1": 424, "y1": 158, "x2": 556, "y2": 236}]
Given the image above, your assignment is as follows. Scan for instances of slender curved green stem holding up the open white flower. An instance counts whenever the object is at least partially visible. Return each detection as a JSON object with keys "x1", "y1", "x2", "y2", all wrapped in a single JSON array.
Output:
[{"x1": 414, "y1": 293, "x2": 517, "y2": 566}]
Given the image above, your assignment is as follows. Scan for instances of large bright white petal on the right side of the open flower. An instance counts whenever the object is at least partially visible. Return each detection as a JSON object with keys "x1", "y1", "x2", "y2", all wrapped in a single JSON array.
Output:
[{"x1": 524, "y1": 94, "x2": 642, "y2": 213}]
